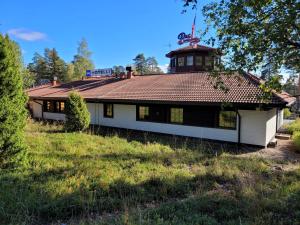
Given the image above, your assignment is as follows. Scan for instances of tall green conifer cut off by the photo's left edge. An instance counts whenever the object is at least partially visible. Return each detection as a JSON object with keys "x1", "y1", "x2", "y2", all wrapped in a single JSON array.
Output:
[{"x1": 0, "y1": 34, "x2": 27, "y2": 162}]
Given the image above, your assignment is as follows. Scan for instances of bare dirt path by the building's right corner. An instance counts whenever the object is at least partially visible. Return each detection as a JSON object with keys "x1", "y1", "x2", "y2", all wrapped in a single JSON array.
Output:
[{"x1": 238, "y1": 140, "x2": 300, "y2": 171}]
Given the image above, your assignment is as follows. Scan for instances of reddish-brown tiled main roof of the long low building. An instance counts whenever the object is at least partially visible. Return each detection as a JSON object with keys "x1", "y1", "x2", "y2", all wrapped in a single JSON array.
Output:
[{"x1": 27, "y1": 72, "x2": 293, "y2": 104}]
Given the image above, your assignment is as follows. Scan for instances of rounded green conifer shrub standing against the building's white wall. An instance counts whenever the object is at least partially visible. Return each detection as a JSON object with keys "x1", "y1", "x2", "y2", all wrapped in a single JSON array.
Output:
[{"x1": 65, "y1": 92, "x2": 90, "y2": 132}]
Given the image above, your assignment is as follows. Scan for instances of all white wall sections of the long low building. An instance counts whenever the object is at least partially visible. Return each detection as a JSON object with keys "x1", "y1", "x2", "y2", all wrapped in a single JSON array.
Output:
[{"x1": 33, "y1": 100, "x2": 276, "y2": 146}]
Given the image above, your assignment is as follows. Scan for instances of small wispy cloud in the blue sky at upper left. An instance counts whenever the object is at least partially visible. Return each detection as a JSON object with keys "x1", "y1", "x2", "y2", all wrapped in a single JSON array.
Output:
[{"x1": 7, "y1": 28, "x2": 47, "y2": 41}]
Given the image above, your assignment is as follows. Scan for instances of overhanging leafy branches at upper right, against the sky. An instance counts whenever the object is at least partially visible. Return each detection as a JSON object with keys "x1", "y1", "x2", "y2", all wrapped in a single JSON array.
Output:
[{"x1": 184, "y1": 0, "x2": 300, "y2": 72}]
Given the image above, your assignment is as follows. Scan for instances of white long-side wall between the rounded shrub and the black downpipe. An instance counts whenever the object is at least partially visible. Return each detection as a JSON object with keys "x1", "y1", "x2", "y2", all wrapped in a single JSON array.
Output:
[{"x1": 87, "y1": 103, "x2": 238, "y2": 142}]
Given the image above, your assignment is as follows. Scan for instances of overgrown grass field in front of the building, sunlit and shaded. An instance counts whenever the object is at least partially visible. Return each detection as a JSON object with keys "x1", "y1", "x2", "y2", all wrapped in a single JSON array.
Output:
[{"x1": 0, "y1": 122, "x2": 300, "y2": 225}]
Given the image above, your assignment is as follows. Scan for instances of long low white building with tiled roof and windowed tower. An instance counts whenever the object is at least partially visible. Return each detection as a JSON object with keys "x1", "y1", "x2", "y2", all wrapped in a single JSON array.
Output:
[{"x1": 28, "y1": 45, "x2": 294, "y2": 146}]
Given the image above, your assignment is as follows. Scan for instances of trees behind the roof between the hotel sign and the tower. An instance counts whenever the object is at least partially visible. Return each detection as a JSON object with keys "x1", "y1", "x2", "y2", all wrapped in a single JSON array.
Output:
[{"x1": 133, "y1": 53, "x2": 163, "y2": 75}]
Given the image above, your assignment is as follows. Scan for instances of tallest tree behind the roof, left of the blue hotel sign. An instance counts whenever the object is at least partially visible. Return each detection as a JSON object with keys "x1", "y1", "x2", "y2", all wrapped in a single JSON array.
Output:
[{"x1": 73, "y1": 38, "x2": 95, "y2": 79}]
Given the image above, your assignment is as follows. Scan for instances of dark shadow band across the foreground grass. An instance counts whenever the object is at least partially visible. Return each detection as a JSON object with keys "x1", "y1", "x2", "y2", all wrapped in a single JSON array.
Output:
[{"x1": 0, "y1": 163, "x2": 300, "y2": 224}]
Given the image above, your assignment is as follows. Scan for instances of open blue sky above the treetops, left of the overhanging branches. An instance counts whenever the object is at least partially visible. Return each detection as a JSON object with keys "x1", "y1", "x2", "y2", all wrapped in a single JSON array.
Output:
[{"x1": 0, "y1": 0, "x2": 211, "y2": 71}]
